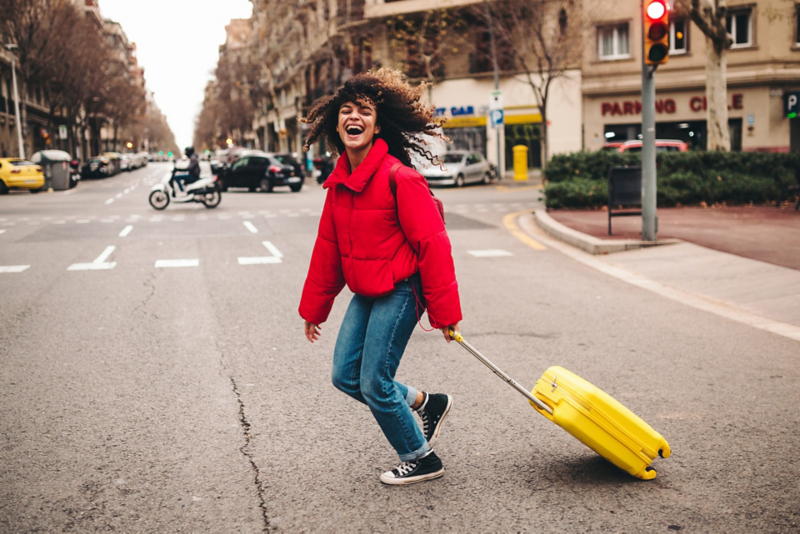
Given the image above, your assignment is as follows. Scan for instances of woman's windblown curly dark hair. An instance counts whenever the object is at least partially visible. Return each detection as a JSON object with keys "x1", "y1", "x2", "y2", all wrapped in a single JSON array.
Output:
[{"x1": 302, "y1": 68, "x2": 447, "y2": 167}]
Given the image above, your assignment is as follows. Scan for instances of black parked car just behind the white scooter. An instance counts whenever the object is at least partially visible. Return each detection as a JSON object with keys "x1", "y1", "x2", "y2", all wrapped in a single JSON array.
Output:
[{"x1": 219, "y1": 150, "x2": 303, "y2": 193}]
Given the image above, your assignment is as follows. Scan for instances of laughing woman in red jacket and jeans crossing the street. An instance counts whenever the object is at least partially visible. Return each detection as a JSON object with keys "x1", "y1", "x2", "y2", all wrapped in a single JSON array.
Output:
[{"x1": 299, "y1": 69, "x2": 461, "y2": 484}]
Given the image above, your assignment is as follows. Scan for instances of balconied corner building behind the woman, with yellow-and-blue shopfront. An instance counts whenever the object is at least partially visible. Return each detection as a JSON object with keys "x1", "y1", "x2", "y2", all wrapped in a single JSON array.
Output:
[{"x1": 245, "y1": 0, "x2": 581, "y2": 167}]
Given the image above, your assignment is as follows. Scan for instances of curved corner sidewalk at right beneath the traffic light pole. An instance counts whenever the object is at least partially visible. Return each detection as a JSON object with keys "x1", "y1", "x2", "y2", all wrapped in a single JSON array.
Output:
[{"x1": 520, "y1": 207, "x2": 800, "y2": 341}]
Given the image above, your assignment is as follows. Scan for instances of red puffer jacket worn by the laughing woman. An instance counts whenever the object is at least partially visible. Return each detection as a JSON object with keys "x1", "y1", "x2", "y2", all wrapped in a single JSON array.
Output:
[{"x1": 299, "y1": 139, "x2": 461, "y2": 328}]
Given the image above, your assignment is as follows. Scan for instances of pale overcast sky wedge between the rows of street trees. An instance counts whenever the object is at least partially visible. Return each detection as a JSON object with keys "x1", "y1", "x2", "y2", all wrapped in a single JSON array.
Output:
[{"x1": 99, "y1": 0, "x2": 253, "y2": 149}]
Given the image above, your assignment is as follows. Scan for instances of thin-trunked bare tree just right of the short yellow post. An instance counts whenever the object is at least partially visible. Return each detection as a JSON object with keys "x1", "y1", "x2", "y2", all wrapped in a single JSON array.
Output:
[{"x1": 474, "y1": 0, "x2": 586, "y2": 167}]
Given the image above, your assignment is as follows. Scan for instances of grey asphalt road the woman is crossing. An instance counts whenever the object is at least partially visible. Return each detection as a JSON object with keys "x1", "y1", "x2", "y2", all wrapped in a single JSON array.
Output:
[{"x1": 0, "y1": 164, "x2": 800, "y2": 532}]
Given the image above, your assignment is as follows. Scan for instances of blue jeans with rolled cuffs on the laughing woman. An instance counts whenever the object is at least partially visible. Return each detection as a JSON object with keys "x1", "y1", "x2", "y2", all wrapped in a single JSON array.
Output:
[{"x1": 332, "y1": 276, "x2": 430, "y2": 462}]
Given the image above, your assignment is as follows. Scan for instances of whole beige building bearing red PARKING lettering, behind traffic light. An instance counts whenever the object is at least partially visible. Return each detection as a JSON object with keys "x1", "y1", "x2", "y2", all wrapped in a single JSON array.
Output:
[{"x1": 582, "y1": 0, "x2": 800, "y2": 152}]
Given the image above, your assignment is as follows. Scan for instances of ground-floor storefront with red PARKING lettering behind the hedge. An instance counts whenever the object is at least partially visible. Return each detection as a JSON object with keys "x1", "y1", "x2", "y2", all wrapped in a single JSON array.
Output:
[{"x1": 584, "y1": 86, "x2": 800, "y2": 152}]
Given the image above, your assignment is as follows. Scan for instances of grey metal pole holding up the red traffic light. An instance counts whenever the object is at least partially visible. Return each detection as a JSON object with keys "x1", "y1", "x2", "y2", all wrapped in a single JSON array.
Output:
[{"x1": 640, "y1": 6, "x2": 658, "y2": 241}]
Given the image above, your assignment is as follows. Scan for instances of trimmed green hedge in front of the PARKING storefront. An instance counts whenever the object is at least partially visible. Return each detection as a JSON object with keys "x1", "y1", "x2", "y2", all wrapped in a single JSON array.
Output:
[{"x1": 544, "y1": 151, "x2": 800, "y2": 208}]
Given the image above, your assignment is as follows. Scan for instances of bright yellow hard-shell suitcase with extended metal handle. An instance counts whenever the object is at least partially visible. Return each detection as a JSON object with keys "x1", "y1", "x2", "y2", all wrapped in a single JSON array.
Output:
[{"x1": 451, "y1": 330, "x2": 670, "y2": 480}]
